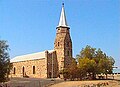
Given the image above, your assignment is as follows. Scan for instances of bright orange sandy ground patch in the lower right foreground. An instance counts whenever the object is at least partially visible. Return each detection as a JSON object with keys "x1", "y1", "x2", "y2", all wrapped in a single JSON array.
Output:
[{"x1": 50, "y1": 80, "x2": 120, "y2": 87}]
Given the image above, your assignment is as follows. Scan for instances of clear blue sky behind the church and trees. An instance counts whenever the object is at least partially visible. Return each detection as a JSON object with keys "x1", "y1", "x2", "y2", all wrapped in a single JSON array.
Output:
[{"x1": 0, "y1": 0, "x2": 120, "y2": 66}]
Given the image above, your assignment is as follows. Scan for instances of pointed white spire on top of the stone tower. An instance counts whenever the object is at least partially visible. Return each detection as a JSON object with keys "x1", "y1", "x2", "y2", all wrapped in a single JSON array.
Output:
[{"x1": 57, "y1": 3, "x2": 69, "y2": 28}]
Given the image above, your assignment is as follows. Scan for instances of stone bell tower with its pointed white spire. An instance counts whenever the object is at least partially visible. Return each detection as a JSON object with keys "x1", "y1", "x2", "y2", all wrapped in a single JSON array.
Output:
[{"x1": 54, "y1": 4, "x2": 72, "y2": 70}]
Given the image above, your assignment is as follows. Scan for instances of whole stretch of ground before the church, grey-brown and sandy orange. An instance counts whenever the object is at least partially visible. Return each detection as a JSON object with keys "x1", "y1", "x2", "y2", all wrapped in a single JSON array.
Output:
[{"x1": 0, "y1": 74, "x2": 120, "y2": 87}]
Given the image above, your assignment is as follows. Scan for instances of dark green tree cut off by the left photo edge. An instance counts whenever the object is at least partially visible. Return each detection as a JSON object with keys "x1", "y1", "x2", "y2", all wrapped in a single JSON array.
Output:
[{"x1": 0, "y1": 40, "x2": 11, "y2": 82}]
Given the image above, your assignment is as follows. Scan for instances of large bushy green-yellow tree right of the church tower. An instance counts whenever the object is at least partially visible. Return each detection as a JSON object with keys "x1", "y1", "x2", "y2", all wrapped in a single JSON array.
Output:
[{"x1": 76, "y1": 45, "x2": 115, "y2": 79}]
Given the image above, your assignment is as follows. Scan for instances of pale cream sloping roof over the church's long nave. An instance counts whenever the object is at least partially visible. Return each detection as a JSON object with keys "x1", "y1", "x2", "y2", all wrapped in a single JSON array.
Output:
[{"x1": 10, "y1": 50, "x2": 54, "y2": 63}]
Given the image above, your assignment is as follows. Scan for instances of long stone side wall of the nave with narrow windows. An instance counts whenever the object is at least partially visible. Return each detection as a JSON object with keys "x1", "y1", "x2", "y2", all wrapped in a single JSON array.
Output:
[{"x1": 11, "y1": 58, "x2": 47, "y2": 78}]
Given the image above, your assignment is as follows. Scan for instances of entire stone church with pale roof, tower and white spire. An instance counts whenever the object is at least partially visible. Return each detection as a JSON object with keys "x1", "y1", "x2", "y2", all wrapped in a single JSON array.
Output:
[{"x1": 10, "y1": 5, "x2": 72, "y2": 78}]
